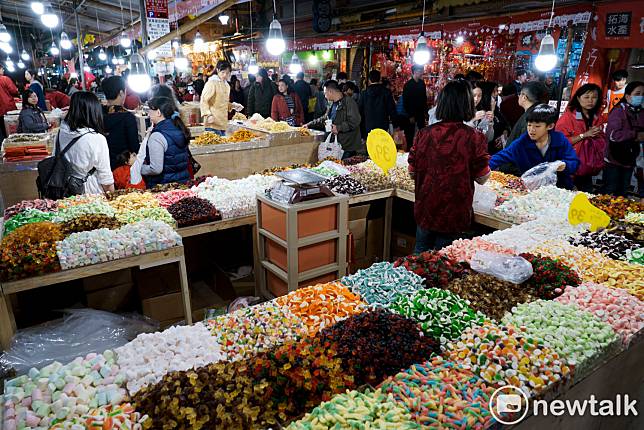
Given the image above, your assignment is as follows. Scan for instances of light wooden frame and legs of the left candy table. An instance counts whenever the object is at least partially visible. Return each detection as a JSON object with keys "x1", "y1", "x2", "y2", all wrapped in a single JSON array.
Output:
[{"x1": 0, "y1": 246, "x2": 192, "y2": 350}]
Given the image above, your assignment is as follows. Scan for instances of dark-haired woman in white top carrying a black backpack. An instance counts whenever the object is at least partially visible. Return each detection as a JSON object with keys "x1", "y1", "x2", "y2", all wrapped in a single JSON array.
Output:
[{"x1": 52, "y1": 91, "x2": 114, "y2": 194}]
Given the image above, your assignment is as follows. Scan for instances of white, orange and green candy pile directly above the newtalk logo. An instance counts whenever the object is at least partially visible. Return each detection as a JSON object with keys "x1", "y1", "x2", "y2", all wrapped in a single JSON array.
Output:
[{"x1": 444, "y1": 322, "x2": 573, "y2": 397}]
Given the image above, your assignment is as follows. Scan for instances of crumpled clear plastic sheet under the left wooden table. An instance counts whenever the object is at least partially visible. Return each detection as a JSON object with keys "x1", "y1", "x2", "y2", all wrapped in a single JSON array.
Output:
[{"x1": 0, "y1": 309, "x2": 159, "y2": 375}]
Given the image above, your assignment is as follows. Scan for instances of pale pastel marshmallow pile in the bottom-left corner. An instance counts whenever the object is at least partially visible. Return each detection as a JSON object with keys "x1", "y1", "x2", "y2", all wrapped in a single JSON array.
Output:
[{"x1": 4, "y1": 350, "x2": 127, "y2": 430}]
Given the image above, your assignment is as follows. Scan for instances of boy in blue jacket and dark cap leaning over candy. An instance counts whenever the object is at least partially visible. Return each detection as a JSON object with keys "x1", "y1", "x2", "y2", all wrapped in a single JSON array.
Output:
[{"x1": 490, "y1": 103, "x2": 579, "y2": 189}]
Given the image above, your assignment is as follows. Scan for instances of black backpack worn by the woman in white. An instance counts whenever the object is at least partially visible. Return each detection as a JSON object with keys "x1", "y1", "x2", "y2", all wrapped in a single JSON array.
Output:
[{"x1": 36, "y1": 133, "x2": 96, "y2": 200}]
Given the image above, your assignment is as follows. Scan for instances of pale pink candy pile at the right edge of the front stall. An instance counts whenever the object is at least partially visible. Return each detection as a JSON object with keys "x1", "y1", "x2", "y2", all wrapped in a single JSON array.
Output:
[{"x1": 556, "y1": 283, "x2": 644, "y2": 346}]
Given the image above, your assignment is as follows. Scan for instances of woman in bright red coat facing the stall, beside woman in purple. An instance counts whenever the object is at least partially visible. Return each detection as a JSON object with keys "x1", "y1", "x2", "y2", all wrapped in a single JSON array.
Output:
[{"x1": 555, "y1": 84, "x2": 607, "y2": 193}]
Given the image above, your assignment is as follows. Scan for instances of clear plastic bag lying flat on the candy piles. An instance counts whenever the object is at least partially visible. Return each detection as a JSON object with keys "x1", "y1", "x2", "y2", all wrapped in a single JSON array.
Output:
[{"x1": 470, "y1": 251, "x2": 533, "y2": 284}]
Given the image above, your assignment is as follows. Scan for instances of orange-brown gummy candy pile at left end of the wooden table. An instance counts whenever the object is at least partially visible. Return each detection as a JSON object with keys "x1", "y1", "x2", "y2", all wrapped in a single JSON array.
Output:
[{"x1": 0, "y1": 221, "x2": 63, "y2": 281}]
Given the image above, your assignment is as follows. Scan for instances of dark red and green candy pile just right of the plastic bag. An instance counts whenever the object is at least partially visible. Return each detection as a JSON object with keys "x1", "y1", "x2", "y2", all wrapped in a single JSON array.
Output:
[{"x1": 521, "y1": 254, "x2": 581, "y2": 300}]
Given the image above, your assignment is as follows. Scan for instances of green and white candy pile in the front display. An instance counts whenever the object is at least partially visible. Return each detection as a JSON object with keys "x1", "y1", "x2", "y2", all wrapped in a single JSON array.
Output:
[{"x1": 390, "y1": 288, "x2": 485, "y2": 344}]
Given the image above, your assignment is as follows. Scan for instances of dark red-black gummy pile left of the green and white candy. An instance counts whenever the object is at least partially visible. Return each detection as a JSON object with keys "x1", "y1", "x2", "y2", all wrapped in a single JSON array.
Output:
[{"x1": 319, "y1": 309, "x2": 440, "y2": 385}]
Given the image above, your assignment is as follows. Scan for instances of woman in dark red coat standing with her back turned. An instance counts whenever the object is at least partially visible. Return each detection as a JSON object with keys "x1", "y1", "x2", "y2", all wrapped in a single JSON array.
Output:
[{"x1": 409, "y1": 81, "x2": 490, "y2": 253}]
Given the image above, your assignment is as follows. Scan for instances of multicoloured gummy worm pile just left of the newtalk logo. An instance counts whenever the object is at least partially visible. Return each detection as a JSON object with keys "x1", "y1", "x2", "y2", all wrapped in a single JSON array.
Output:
[{"x1": 380, "y1": 357, "x2": 494, "y2": 429}]
